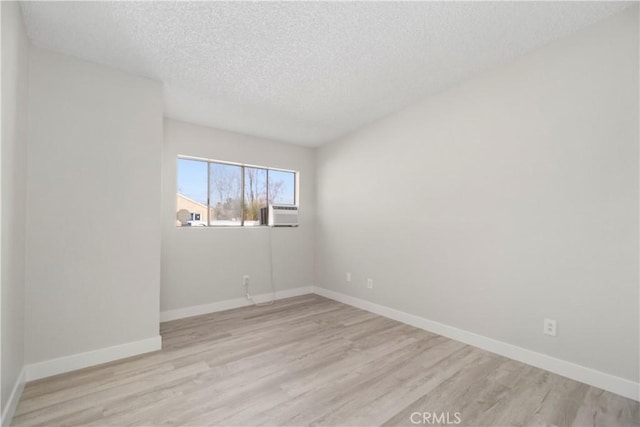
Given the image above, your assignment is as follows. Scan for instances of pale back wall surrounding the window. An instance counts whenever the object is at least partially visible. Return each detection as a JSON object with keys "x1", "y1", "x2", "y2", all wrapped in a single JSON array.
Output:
[{"x1": 161, "y1": 118, "x2": 316, "y2": 311}]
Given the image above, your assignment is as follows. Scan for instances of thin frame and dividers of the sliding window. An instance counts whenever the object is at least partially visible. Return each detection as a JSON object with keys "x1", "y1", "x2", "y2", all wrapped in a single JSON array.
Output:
[{"x1": 175, "y1": 154, "x2": 300, "y2": 228}]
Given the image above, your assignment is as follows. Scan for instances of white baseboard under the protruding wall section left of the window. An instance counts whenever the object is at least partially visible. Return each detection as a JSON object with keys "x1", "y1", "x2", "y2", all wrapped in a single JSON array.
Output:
[{"x1": 26, "y1": 335, "x2": 162, "y2": 381}]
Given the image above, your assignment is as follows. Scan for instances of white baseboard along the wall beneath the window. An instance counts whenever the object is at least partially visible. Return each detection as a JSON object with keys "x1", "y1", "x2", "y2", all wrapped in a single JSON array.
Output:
[{"x1": 160, "y1": 286, "x2": 313, "y2": 322}]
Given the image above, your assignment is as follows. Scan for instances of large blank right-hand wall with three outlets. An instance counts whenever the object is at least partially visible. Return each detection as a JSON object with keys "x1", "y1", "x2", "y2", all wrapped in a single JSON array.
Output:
[{"x1": 317, "y1": 7, "x2": 639, "y2": 382}]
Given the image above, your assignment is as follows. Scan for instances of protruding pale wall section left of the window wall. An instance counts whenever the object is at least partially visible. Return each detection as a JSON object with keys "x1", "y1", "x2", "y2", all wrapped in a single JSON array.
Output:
[{"x1": 26, "y1": 48, "x2": 163, "y2": 363}]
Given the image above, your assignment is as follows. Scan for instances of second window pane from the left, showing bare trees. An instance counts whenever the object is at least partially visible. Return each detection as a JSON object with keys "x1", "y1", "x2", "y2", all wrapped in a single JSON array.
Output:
[{"x1": 209, "y1": 163, "x2": 242, "y2": 225}]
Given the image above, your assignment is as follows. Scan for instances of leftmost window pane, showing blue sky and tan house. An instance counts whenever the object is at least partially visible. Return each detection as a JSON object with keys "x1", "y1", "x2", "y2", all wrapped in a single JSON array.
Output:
[{"x1": 176, "y1": 159, "x2": 207, "y2": 227}]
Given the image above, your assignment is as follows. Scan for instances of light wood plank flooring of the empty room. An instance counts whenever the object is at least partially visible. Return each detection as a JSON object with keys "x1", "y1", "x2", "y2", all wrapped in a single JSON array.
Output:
[{"x1": 13, "y1": 295, "x2": 640, "y2": 426}]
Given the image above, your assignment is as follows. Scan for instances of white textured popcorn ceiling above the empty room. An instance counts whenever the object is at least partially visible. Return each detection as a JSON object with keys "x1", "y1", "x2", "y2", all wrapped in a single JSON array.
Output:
[{"x1": 22, "y1": 2, "x2": 629, "y2": 145}]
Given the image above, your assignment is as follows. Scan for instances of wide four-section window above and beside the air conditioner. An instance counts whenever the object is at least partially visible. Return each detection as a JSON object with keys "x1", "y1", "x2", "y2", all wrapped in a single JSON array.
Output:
[{"x1": 176, "y1": 157, "x2": 297, "y2": 227}]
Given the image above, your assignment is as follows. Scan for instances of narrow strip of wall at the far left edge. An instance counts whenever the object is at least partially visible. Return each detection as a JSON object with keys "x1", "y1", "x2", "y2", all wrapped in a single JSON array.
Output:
[{"x1": 0, "y1": 2, "x2": 29, "y2": 414}]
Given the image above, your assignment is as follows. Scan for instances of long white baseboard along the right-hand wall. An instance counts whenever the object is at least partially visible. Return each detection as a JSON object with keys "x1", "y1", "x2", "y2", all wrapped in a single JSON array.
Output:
[{"x1": 314, "y1": 286, "x2": 640, "y2": 400}]
